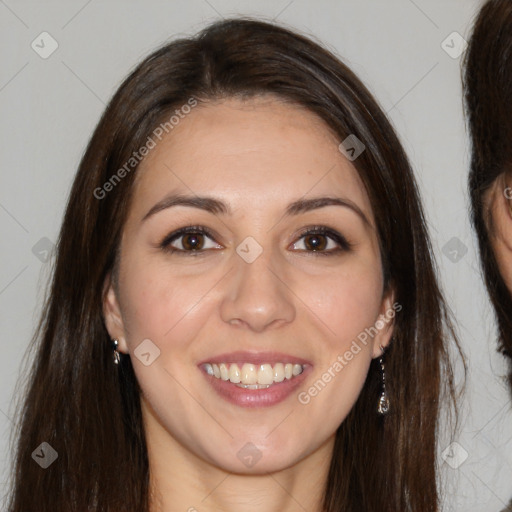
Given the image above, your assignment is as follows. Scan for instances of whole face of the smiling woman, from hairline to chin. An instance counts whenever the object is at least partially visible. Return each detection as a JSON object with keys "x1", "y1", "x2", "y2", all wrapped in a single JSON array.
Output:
[{"x1": 104, "y1": 97, "x2": 393, "y2": 473}]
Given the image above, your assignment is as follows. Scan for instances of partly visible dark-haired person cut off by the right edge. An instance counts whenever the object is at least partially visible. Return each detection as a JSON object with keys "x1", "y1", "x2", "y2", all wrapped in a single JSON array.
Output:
[{"x1": 464, "y1": 0, "x2": 512, "y2": 511}]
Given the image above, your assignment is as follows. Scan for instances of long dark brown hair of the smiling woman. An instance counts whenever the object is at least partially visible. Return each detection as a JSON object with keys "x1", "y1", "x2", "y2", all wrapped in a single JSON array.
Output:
[{"x1": 9, "y1": 19, "x2": 464, "y2": 512}]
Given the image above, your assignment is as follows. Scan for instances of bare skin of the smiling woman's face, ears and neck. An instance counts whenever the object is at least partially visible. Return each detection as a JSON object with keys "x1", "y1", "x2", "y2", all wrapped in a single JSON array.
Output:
[{"x1": 104, "y1": 96, "x2": 393, "y2": 512}]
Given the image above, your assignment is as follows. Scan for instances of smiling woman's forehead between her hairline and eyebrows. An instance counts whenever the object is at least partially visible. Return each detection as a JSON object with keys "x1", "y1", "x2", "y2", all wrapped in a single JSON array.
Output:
[{"x1": 133, "y1": 97, "x2": 373, "y2": 224}]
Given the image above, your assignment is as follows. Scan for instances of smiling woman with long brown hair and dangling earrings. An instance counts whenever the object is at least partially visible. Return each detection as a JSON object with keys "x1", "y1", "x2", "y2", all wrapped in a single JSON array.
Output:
[{"x1": 9, "y1": 19, "x2": 462, "y2": 512}]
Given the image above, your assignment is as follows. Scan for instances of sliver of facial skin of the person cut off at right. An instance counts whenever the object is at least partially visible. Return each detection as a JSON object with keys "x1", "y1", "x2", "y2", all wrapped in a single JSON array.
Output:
[{"x1": 484, "y1": 174, "x2": 512, "y2": 293}]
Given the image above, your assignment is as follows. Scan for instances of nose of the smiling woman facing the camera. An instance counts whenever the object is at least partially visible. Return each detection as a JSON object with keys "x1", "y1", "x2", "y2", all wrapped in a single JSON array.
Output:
[{"x1": 220, "y1": 245, "x2": 296, "y2": 332}]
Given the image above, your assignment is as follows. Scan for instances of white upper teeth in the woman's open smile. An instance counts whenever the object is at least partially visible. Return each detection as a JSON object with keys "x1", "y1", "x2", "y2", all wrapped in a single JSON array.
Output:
[{"x1": 204, "y1": 363, "x2": 304, "y2": 385}]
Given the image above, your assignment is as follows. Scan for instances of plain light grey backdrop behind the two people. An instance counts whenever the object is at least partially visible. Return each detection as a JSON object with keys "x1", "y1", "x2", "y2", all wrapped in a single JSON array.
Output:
[{"x1": 0, "y1": 0, "x2": 512, "y2": 512}]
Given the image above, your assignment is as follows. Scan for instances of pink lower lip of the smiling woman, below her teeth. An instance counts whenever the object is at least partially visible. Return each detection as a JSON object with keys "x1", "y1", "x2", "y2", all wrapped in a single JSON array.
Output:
[{"x1": 201, "y1": 365, "x2": 311, "y2": 407}]
